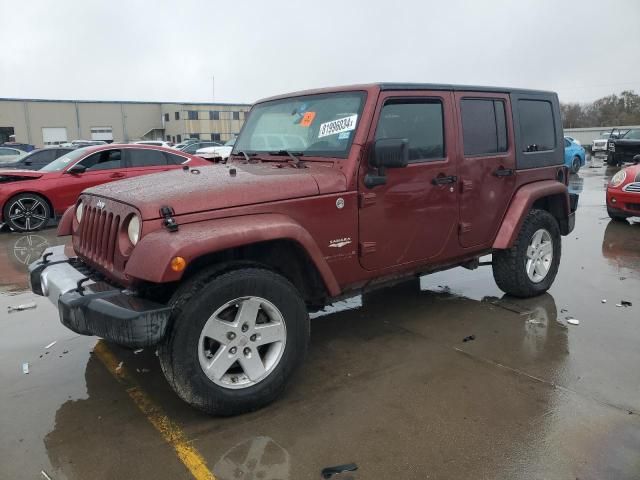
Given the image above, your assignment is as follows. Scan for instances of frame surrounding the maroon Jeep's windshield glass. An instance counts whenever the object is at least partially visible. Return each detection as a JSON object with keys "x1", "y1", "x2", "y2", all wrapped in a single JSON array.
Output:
[{"x1": 231, "y1": 89, "x2": 368, "y2": 161}]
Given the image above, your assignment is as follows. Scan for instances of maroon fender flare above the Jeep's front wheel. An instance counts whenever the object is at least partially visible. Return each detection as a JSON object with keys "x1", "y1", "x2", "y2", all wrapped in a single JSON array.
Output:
[{"x1": 125, "y1": 214, "x2": 340, "y2": 296}]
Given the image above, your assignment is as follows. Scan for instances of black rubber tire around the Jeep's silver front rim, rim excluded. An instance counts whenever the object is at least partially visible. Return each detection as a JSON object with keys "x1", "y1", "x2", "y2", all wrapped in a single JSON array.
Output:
[{"x1": 158, "y1": 268, "x2": 309, "y2": 416}]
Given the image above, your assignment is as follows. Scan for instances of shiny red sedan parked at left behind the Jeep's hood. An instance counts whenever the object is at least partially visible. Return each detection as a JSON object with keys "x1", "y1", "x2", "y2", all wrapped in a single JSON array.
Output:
[{"x1": 0, "y1": 144, "x2": 211, "y2": 232}]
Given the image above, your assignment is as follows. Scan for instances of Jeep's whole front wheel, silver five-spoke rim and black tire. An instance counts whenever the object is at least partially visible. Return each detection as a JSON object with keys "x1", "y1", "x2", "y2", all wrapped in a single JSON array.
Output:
[{"x1": 158, "y1": 268, "x2": 309, "y2": 415}]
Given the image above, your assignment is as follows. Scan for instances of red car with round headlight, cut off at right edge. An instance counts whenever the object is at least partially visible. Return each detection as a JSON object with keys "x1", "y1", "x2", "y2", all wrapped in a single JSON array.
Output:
[{"x1": 607, "y1": 165, "x2": 640, "y2": 220}]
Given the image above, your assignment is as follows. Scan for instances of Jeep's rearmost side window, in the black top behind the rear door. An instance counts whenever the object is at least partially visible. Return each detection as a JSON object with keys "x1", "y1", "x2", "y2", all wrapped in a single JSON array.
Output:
[{"x1": 518, "y1": 100, "x2": 556, "y2": 152}]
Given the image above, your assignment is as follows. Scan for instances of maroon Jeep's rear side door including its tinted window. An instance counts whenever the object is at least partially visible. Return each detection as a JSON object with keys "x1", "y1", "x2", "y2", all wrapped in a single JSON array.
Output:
[{"x1": 455, "y1": 92, "x2": 516, "y2": 248}]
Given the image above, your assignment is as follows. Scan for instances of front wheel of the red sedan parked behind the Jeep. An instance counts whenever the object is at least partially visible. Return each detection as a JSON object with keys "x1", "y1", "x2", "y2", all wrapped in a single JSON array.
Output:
[{"x1": 2, "y1": 193, "x2": 51, "y2": 232}]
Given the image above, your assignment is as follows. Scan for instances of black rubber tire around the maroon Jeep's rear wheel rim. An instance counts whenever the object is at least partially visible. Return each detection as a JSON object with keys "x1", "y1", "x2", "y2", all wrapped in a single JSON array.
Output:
[{"x1": 492, "y1": 210, "x2": 562, "y2": 298}]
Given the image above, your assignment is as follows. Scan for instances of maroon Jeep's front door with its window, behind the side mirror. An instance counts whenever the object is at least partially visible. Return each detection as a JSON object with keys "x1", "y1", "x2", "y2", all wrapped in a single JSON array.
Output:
[{"x1": 359, "y1": 91, "x2": 458, "y2": 270}]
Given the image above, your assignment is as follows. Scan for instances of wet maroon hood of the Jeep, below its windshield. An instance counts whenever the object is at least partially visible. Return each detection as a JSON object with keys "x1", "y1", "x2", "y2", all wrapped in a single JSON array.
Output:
[{"x1": 85, "y1": 162, "x2": 346, "y2": 220}]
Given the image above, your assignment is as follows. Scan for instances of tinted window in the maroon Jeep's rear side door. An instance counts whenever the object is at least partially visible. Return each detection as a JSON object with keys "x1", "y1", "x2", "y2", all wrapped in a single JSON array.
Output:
[{"x1": 460, "y1": 98, "x2": 508, "y2": 156}]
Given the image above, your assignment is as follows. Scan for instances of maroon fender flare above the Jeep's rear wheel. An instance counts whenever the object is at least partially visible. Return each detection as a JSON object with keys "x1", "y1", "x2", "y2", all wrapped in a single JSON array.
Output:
[{"x1": 493, "y1": 180, "x2": 570, "y2": 249}]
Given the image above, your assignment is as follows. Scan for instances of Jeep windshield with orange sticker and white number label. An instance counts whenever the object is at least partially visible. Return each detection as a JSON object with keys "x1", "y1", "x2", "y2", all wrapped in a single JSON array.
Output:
[{"x1": 233, "y1": 92, "x2": 365, "y2": 158}]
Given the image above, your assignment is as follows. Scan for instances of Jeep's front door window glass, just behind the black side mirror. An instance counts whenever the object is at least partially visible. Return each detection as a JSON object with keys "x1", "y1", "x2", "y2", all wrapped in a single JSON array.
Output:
[{"x1": 376, "y1": 99, "x2": 445, "y2": 163}]
